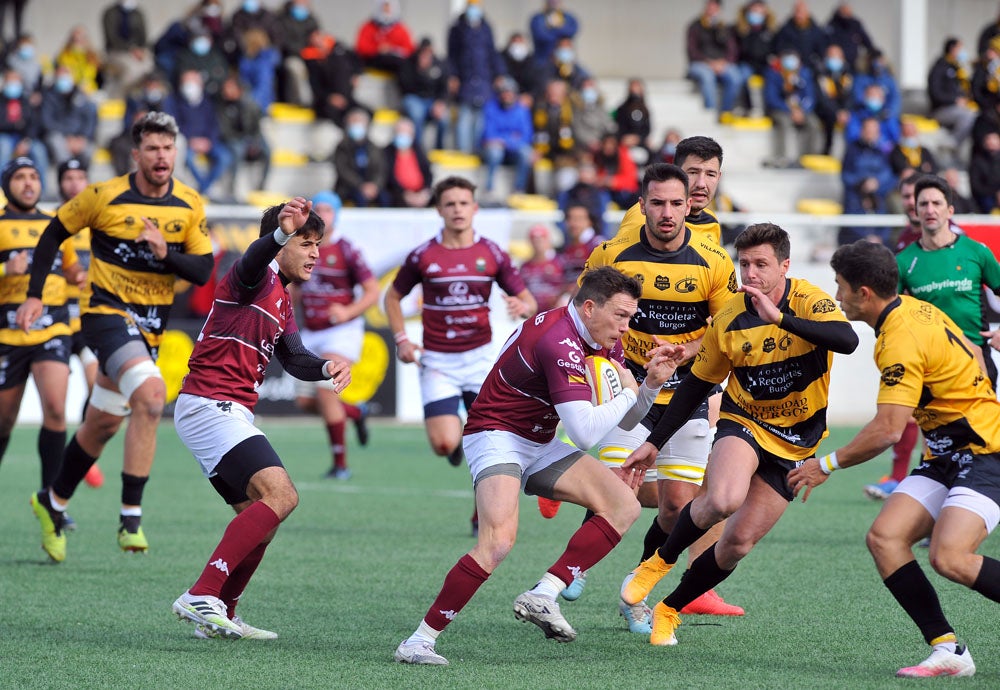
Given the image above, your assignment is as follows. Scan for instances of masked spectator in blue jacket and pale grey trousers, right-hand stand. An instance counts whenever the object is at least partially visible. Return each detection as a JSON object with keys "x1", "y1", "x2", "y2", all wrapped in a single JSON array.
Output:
[{"x1": 764, "y1": 49, "x2": 822, "y2": 168}]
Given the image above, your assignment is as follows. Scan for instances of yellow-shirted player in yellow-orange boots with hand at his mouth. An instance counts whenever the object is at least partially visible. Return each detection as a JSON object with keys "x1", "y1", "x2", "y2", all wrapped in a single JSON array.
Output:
[{"x1": 622, "y1": 223, "x2": 858, "y2": 645}]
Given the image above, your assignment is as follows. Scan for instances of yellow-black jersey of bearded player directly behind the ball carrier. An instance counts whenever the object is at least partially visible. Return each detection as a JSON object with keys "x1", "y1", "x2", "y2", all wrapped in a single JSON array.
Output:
[{"x1": 581, "y1": 229, "x2": 737, "y2": 404}]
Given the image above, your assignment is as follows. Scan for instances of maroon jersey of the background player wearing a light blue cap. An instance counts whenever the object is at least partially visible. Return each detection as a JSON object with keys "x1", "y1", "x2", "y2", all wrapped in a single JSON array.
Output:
[{"x1": 302, "y1": 237, "x2": 372, "y2": 331}]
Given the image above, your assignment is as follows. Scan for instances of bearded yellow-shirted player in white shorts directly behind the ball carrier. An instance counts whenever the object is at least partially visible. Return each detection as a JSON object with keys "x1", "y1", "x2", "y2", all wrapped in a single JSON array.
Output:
[{"x1": 563, "y1": 163, "x2": 744, "y2": 624}]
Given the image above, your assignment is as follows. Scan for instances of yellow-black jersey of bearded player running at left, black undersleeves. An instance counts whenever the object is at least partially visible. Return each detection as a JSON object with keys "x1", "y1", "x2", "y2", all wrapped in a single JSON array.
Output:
[{"x1": 57, "y1": 173, "x2": 212, "y2": 347}]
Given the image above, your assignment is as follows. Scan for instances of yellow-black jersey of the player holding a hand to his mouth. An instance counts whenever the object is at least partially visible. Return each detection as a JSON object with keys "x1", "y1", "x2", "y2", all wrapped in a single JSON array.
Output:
[{"x1": 691, "y1": 278, "x2": 847, "y2": 460}]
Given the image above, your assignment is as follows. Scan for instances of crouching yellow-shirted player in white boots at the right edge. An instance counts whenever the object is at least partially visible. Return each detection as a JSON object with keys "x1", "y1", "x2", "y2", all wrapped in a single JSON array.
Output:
[{"x1": 788, "y1": 241, "x2": 1000, "y2": 678}]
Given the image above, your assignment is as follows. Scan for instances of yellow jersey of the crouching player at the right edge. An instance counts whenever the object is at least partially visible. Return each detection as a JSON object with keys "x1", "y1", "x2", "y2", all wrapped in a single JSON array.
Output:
[{"x1": 875, "y1": 295, "x2": 1000, "y2": 458}]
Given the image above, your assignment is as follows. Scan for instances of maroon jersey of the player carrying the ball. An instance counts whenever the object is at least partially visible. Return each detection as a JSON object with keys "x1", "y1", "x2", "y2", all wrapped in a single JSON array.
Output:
[{"x1": 465, "y1": 307, "x2": 624, "y2": 443}]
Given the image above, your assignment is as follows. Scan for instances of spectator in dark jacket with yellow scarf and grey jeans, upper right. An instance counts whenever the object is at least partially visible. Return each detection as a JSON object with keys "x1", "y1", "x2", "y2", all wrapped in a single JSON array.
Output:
[{"x1": 927, "y1": 36, "x2": 976, "y2": 146}]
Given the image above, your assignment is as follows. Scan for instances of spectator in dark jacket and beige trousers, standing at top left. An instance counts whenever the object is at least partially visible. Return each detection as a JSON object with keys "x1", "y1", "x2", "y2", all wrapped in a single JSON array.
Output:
[{"x1": 101, "y1": 0, "x2": 153, "y2": 98}]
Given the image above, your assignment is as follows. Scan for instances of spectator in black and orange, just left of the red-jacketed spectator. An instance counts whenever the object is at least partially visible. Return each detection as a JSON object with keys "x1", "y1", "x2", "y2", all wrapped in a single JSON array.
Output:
[{"x1": 302, "y1": 29, "x2": 371, "y2": 130}]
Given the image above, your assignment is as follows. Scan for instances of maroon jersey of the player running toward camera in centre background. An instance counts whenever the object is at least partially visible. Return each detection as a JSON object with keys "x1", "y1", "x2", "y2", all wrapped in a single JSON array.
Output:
[{"x1": 392, "y1": 235, "x2": 524, "y2": 352}]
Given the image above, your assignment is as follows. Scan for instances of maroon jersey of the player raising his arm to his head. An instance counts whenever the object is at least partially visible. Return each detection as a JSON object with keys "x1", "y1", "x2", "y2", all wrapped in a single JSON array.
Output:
[{"x1": 181, "y1": 264, "x2": 298, "y2": 412}]
